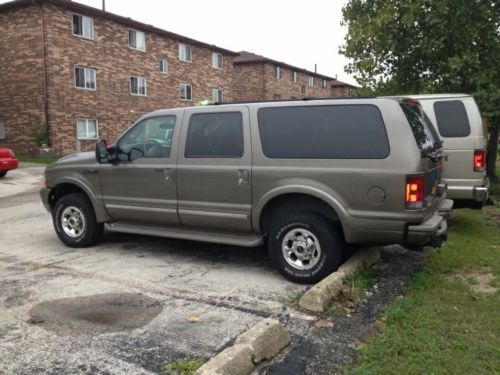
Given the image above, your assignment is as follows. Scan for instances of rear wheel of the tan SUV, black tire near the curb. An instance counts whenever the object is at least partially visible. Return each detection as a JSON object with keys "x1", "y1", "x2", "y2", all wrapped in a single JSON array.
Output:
[{"x1": 267, "y1": 212, "x2": 344, "y2": 284}]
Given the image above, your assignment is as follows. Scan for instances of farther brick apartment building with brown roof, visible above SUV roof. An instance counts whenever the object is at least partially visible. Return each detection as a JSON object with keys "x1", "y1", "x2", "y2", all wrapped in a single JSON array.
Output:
[{"x1": 233, "y1": 51, "x2": 334, "y2": 101}]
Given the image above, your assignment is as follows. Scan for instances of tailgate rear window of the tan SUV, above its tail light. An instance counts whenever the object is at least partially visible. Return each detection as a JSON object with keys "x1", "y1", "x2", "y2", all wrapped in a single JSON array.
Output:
[{"x1": 400, "y1": 102, "x2": 439, "y2": 155}]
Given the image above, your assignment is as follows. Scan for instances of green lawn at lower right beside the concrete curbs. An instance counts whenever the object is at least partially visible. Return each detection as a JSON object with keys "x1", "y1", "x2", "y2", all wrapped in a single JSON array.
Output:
[{"x1": 345, "y1": 177, "x2": 500, "y2": 374}]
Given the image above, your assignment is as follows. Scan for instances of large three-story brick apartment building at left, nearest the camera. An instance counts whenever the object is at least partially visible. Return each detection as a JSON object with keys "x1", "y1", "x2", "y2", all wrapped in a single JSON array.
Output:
[{"x1": 0, "y1": 0, "x2": 236, "y2": 154}]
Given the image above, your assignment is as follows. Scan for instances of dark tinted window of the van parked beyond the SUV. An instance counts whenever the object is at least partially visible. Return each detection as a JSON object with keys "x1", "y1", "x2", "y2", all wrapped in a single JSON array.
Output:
[{"x1": 434, "y1": 100, "x2": 470, "y2": 137}]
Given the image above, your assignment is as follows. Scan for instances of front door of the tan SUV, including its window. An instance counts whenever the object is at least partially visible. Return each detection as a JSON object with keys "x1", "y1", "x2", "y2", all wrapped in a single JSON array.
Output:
[{"x1": 101, "y1": 114, "x2": 179, "y2": 226}]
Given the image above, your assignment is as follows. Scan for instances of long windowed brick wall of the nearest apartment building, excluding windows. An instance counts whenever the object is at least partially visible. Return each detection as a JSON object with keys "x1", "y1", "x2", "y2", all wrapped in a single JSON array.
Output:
[{"x1": 46, "y1": 4, "x2": 233, "y2": 154}]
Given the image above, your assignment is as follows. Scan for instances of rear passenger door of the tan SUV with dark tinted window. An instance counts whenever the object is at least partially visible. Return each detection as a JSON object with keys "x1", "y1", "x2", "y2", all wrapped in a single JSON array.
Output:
[{"x1": 177, "y1": 106, "x2": 252, "y2": 232}]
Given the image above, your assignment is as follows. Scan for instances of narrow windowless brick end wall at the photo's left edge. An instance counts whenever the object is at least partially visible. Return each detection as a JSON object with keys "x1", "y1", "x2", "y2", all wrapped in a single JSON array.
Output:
[{"x1": 0, "y1": 5, "x2": 45, "y2": 151}]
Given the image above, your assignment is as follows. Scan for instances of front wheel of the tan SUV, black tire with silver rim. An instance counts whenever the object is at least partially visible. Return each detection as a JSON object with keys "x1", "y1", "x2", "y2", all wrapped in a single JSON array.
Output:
[{"x1": 52, "y1": 193, "x2": 104, "y2": 247}]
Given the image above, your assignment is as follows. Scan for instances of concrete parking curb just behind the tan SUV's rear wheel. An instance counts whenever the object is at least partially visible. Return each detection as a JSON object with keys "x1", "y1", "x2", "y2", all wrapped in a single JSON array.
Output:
[{"x1": 299, "y1": 247, "x2": 380, "y2": 312}]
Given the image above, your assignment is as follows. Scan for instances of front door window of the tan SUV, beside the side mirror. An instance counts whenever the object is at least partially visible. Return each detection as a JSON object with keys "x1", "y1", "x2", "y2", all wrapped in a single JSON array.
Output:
[{"x1": 118, "y1": 116, "x2": 176, "y2": 160}]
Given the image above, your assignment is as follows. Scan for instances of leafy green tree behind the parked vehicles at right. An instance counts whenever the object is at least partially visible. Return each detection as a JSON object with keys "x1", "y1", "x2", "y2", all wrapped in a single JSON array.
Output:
[{"x1": 340, "y1": 0, "x2": 500, "y2": 177}]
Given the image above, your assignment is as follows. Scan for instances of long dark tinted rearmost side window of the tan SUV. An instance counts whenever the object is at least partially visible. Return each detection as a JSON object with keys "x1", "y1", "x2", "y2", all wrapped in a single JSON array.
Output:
[{"x1": 258, "y1": 105, "x2": 389, "y2": 159}]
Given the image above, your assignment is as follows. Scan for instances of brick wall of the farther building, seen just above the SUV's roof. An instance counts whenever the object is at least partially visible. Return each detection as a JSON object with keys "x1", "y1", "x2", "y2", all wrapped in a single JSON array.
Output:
[{"x1": 234, "y1": 62, "x2": 331, "y2": 101}]
